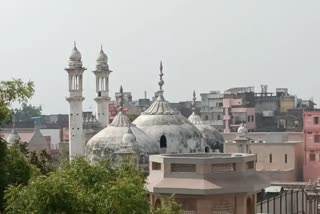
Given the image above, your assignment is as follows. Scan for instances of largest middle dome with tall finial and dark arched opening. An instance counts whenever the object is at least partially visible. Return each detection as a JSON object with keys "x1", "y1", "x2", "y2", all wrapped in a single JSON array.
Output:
[{"x1": 133, "y1": 64, "x2": 204, "y2": 153}]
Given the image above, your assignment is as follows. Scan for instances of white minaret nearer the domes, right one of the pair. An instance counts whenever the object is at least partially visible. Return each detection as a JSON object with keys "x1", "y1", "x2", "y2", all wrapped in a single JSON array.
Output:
[{"x1": 93, "y1": 46, "x2": 112, "y2": 128}]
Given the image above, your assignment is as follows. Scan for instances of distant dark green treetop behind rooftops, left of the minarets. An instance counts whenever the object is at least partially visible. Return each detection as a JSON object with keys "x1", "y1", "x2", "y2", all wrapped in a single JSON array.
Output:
[{"x1": 15, "y1": 103, "x2": 42, "y2": 121}]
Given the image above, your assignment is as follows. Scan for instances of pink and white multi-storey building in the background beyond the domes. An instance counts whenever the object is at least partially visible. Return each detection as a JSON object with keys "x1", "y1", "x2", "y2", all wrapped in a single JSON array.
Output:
[{"x1": 223, "y1": 87, "x2": 256, "y2": 133}]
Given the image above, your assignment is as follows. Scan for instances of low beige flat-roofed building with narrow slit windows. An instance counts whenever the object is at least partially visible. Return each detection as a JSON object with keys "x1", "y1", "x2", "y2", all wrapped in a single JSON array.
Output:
[{"x1": 224, "y1": 127, "x2": 303, "y2": 181}]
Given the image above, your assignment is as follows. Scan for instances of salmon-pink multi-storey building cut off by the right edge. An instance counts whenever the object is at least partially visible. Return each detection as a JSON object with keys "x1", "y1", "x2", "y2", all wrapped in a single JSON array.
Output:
[{"x1": 303, "y1": 111, "x2": 320, "y2": 181}]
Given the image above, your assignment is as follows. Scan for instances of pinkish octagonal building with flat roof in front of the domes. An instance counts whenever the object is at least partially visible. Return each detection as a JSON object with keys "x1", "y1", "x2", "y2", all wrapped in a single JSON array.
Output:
[{"x1": 146, "y1": 153, "x2": 269, "y2": 214}]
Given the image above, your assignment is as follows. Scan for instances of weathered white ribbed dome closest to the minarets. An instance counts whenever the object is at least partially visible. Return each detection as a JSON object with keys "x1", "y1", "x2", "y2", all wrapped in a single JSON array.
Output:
[{"x1": 86, "y1": 111, "x2": 159, "y2": 160}]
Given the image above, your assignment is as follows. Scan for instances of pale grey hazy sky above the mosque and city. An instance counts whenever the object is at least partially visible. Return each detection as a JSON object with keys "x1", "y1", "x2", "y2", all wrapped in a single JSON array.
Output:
[{"x1": 0, "y1": 0, "x2": 320, "y2": 114}]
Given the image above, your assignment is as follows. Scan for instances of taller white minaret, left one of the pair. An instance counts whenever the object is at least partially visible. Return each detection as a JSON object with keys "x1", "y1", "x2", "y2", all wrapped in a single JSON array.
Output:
[{"x1": 65, "y1": 43, "x2": 86, "y2": 159}]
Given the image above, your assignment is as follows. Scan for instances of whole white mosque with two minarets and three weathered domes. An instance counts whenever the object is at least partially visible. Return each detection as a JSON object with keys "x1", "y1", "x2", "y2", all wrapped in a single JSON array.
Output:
[{"x1": 65, "y1": 45, "x2": 224, "y2": 162}]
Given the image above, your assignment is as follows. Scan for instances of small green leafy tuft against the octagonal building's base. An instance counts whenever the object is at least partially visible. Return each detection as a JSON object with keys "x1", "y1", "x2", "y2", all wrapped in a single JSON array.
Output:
[{"x1": 152, "y1": 195, "x2": 181, "y2": 214}]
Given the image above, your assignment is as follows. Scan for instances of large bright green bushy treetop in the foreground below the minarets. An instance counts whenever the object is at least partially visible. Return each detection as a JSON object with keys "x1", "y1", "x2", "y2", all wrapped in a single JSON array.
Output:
[{"x1": 5, "y1": 159, "x2": 149, "y2": 214}]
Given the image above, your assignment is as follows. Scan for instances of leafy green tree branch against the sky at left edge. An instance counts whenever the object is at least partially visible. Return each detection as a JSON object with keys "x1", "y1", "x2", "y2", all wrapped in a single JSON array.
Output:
[{"x1": 0, "y1": 79, "x2": 34, "y2": 122}]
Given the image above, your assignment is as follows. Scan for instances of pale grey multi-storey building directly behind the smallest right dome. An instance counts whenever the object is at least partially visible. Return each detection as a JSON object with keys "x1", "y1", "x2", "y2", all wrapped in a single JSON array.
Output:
[{"x1": 200, "y1": 91, "x2": 224, "y2": 132}]
